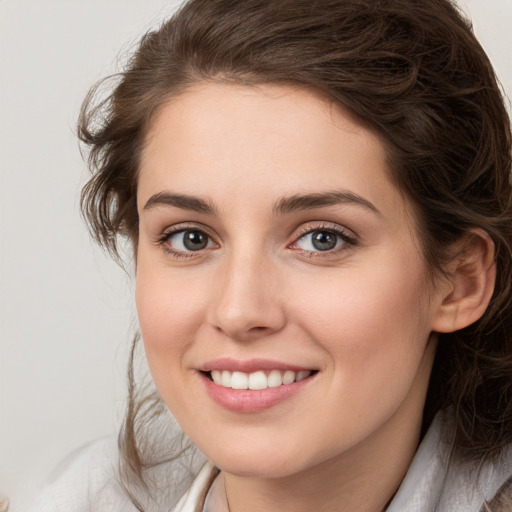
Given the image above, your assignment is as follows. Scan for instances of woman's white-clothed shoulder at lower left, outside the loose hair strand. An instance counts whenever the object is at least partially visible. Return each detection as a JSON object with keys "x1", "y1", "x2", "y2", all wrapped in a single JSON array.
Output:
[{"x1": 26, "y1": 438, "x2": 137, "y2": 512}]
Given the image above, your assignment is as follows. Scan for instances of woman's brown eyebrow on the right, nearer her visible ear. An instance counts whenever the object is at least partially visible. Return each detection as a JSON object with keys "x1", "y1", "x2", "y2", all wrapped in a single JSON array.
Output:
[{"x1": 273, "y1": 190, "x2": 382, "y2": 216}]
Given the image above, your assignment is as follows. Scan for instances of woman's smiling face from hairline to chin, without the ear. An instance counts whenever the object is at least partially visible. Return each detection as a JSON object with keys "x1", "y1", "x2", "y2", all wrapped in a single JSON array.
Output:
[{"x1": 136, "y1": 83, "x2": 439, "y2": 476}]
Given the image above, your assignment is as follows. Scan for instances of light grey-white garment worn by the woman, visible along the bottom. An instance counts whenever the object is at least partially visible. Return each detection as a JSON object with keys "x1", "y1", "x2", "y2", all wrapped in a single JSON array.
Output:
[{"x1": 30, "y1": 412, "x2": 512, "y2": 512}]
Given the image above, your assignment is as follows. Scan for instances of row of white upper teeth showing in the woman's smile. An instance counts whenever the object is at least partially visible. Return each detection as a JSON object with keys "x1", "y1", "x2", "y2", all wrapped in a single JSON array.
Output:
[{"x1": 210, "y1": 370, "x2": 311, "y2": 390}]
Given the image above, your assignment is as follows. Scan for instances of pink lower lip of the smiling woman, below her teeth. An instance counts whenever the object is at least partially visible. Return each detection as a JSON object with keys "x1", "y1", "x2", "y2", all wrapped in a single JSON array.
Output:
[{"x1": 200, "y1": 373, "x2": 316, "y2": 413}]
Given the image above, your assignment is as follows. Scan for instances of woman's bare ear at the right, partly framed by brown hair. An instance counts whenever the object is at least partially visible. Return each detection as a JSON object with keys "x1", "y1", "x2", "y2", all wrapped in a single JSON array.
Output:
[{"x1": 432, "y1": 229, "x2": 496, "y2": 332}]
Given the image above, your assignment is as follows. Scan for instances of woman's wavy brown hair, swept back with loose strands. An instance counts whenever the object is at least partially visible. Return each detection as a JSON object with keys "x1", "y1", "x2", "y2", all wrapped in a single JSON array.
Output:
[{"x1": 79, "y1": 0, "x2": 512, "y2": 506}]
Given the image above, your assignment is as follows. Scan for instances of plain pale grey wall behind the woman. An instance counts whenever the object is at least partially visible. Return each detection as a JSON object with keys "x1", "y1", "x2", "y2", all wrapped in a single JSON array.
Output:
[{"x1": 0, "y1": 0, "x2": 512, "y2": 512}]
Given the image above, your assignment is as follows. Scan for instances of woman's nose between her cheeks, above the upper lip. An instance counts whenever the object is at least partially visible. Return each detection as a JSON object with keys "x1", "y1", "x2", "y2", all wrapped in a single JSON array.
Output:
[{"x1": 211, "y1": 251, "x2": 286, "y2": 341}]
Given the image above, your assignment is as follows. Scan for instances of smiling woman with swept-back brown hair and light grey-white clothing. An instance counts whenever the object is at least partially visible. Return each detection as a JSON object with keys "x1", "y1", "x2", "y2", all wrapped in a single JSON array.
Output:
[{"x1": 29, "y1": 0, "x2": 512, "y2": 512}]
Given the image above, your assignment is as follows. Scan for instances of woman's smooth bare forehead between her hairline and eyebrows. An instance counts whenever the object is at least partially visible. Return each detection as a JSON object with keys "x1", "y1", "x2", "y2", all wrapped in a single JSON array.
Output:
[{"x1": 138, "y1": 83, "x2": 403, "y2": 219}]
